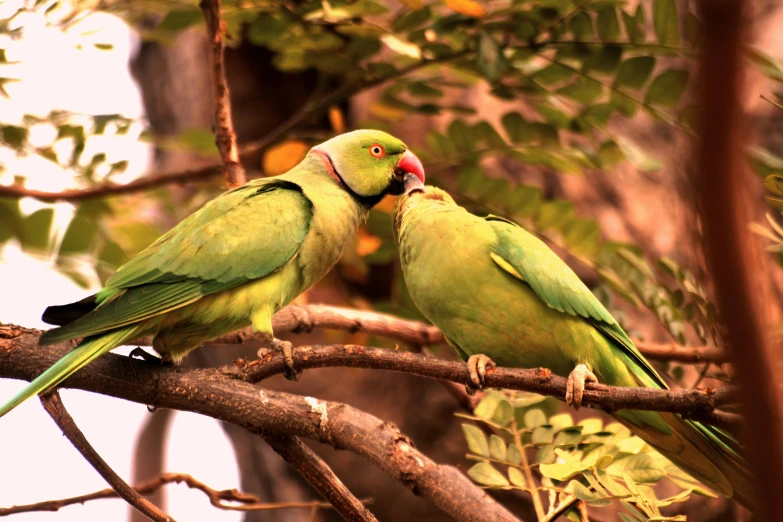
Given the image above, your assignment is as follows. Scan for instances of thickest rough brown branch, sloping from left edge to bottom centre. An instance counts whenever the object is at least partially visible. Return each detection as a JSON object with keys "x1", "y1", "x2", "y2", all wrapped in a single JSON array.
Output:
[{"x1": 0, "y1": 325, "x2": 528, "y2": 522}]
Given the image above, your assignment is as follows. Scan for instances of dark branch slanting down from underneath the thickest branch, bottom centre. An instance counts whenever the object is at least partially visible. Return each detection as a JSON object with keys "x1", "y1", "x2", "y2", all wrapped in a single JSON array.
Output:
[{"x1": 265, "y1": 437, "x2": 378, "y2": 522}]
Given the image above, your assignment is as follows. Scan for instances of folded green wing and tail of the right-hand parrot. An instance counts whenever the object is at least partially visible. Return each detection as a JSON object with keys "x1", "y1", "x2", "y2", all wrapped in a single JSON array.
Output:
[{"x1": 486, "y1": 216, "x2": 752, "y2": 505}]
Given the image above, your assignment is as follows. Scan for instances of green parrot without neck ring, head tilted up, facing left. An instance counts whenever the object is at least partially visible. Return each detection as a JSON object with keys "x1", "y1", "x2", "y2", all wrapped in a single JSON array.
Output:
[{"x1": 392, "y1": 176, "x2": 754, "y2": 506}]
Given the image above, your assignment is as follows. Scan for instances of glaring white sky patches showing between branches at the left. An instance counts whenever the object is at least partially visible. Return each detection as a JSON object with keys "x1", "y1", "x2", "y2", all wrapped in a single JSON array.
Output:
[{"x1": 0, "y1": 1, "x2": 241, "y2": 522}]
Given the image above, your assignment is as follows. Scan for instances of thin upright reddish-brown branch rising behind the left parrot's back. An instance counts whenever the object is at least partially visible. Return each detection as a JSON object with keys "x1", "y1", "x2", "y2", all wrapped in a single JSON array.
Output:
[{"x1": 199, "y1": 0, "x2": 246, "y2": 187}]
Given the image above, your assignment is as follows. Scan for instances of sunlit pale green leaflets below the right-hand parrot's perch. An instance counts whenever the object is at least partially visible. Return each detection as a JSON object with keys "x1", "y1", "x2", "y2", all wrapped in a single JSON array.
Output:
[{"x1": 460, "y1": 391, "x2": 713, "y2": 522}]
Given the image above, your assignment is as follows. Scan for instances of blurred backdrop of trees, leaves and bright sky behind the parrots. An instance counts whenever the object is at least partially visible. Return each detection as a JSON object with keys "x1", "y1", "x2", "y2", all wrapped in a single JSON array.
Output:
[{"x1": 0, "y1": 0, "x2": 783, "y2": 521}]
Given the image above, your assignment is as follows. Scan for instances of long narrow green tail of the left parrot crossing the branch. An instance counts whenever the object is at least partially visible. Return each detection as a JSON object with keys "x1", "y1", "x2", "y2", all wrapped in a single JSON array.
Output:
[{"x1": 0, "y1": 325, "x2": 139, "y2": 417}]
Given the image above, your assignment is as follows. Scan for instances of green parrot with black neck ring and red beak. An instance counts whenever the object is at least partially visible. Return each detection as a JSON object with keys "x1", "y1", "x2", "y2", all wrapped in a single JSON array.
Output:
[{"x1": 0, "y1": 130, "x2": 424, "y2": 417}]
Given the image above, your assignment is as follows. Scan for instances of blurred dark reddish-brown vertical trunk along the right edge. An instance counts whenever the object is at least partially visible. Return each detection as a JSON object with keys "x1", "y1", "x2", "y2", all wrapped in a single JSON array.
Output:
[{"x1": 695, "y1": 0, "x2": 783, "y2": 520}]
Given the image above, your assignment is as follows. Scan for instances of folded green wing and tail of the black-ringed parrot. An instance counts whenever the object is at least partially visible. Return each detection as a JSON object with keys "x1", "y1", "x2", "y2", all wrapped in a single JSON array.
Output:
[{"x1": 0, "y1": 178, "x2": 313, "y2": 417}]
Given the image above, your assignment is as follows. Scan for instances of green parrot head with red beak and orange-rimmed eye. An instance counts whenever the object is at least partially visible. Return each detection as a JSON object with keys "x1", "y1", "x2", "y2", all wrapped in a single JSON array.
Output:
[{"x1": 310, "y1": 129, "x2": 424, "y2": 206}]
